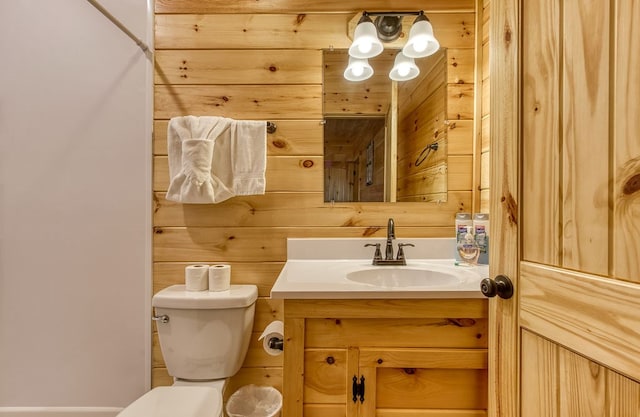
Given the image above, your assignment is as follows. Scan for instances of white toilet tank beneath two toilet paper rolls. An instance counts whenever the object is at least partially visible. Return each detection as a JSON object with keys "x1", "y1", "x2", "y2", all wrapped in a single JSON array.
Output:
[{"x1": 152, "y1": 285, "x2": 258, "y2": 380}]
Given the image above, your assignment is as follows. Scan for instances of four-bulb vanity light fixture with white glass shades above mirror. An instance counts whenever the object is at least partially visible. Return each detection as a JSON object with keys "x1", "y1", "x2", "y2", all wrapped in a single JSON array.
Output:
[{"x1": 344, "y1": 10, "x2": 440, "y2": 81}]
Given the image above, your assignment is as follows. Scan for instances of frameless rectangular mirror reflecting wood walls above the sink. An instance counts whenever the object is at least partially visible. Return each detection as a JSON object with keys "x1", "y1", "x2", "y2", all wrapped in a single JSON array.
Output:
[{"x1": 323, "y1": 48, "x2": 448, "y2": 202}]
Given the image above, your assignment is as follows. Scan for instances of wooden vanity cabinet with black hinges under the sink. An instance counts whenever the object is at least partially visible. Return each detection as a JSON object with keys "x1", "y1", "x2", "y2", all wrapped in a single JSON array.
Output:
[{"x1": 283, "y1": 299, "x2": 487, "y2": 417}]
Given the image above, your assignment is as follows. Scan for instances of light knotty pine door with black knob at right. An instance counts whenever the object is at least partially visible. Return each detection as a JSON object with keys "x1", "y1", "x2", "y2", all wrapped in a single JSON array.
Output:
[{"x1": 489, "y1": 0, "x2": 640, "y2": 417}]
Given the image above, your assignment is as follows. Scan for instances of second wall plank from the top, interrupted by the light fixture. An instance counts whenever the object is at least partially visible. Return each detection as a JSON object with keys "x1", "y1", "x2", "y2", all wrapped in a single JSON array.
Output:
[{"x1": 155, "y1": 13, "x2": 475, "y2": 49}]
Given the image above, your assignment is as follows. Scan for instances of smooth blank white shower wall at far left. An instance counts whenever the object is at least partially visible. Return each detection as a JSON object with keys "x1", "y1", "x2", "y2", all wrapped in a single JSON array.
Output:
[{"x1": 0, "y1": 0, "x2": 152, "y2": 415}]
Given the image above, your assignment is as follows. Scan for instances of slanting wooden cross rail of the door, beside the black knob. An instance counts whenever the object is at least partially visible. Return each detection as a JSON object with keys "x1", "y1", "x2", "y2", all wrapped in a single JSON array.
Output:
[{"x1": 520, "y1": 262, "x2": 640, "y2": 380}]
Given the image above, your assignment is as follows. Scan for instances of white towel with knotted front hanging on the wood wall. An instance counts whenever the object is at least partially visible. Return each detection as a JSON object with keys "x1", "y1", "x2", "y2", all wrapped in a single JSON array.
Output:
[{"x1": 167, "y1": 116, "x2": 267, "y2": 204}]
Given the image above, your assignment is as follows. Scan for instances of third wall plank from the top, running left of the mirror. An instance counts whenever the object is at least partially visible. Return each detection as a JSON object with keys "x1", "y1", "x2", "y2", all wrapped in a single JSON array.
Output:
[{"x1": 155, "y1": 49, "x2": 322, "y2": 85}]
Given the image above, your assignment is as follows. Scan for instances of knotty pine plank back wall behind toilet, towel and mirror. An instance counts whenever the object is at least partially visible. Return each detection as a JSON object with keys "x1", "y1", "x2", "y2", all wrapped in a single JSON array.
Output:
[{"x1": 152, "y1": 0, "x2": 475, "y2": 392}]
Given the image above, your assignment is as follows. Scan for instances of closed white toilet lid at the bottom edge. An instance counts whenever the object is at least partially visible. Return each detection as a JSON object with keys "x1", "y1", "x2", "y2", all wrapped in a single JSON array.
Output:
[{"x1": 117, "y1": 386, "x2": 222, "y2": 417}]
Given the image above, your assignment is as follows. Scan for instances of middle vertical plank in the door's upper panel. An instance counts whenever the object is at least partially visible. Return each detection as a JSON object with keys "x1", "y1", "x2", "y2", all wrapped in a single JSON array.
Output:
[{"x1": 561, "y1": 0, "x2": 612, "y2": 275}]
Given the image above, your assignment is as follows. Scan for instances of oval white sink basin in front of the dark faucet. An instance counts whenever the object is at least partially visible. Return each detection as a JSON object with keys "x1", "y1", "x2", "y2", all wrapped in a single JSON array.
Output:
[{"x1": 346, "y1": 266, "x2": 460, "y2": 287}]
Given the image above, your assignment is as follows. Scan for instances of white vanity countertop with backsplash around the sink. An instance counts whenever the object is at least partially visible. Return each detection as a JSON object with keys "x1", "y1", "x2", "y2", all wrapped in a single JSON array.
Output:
[{"x1": 271, "y1": 238, "x2": 489, "y2": 299}]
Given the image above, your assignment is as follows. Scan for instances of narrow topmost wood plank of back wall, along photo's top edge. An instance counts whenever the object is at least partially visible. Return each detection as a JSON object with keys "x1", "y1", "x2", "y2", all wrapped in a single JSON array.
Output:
[{"x1": 155, "y1": 0, "x2": 474, "y2": 13}]
